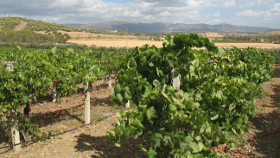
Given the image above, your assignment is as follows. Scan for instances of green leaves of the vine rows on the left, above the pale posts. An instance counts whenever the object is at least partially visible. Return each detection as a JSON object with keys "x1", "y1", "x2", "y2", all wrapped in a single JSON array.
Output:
[{"x1": 0, "y1": 43, "x2": 129, "y2": 143}]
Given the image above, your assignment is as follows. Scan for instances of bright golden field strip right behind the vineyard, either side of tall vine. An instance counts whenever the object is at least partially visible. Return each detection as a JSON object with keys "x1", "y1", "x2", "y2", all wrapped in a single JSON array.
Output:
[{"x1": 68, "y1": 40, "x2": 280, "y2": 48}]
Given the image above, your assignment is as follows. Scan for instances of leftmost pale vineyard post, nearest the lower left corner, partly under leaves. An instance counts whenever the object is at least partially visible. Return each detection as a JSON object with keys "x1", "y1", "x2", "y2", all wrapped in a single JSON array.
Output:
[{"x1": 10, "y1": 108, "x2": 21, "y2": 152}]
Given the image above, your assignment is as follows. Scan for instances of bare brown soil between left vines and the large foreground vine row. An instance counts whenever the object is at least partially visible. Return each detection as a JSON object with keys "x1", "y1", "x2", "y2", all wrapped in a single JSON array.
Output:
[{"x1": 0, "y1": 77, "x2": 148, "y2": 158}]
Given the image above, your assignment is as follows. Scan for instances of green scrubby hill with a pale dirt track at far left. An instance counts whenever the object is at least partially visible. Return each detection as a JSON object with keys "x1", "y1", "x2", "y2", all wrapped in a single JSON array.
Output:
[{"x1": 0, "y1": 17, "x2": 133, "y2": 44}]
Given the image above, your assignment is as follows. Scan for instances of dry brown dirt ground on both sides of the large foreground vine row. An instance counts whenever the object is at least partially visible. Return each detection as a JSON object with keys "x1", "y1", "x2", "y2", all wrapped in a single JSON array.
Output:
[{"x1": 0, "y1": 61, "x2": 280, "y2": 158}]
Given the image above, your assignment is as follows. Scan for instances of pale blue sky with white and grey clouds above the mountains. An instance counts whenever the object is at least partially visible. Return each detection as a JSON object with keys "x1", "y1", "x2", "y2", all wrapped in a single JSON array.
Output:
[{"x1": 0, "y1": 0, "x2": 280, "y2": 29}]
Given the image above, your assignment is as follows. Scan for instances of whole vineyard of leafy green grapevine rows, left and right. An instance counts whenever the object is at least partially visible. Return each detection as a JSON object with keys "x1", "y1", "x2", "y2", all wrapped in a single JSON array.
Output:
[{"x1": 0, "y1": 34, "x2": 275, "y2": 158}]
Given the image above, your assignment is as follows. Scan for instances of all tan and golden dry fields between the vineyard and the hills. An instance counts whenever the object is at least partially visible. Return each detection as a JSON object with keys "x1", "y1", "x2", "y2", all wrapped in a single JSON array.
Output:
[{"x1": 35, "y1": 31, "x2": 280, "y2": 48}]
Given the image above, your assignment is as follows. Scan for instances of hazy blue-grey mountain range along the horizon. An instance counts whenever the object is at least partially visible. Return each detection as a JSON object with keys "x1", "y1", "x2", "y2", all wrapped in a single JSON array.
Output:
[{"x1": 80, "y1": 21, "x2": 278, "y2": 33}]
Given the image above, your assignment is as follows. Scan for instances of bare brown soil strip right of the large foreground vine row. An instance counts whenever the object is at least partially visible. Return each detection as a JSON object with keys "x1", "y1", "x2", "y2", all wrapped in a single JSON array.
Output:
[{"x1": 228, "y1": 61, "x2": 280, "y2": 158}]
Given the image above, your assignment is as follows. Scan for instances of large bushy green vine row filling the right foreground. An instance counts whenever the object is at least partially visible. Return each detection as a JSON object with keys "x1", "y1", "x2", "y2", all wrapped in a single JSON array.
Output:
[{"x1": 106, "y1": 34, "x2": 275, "y2": 157}]
